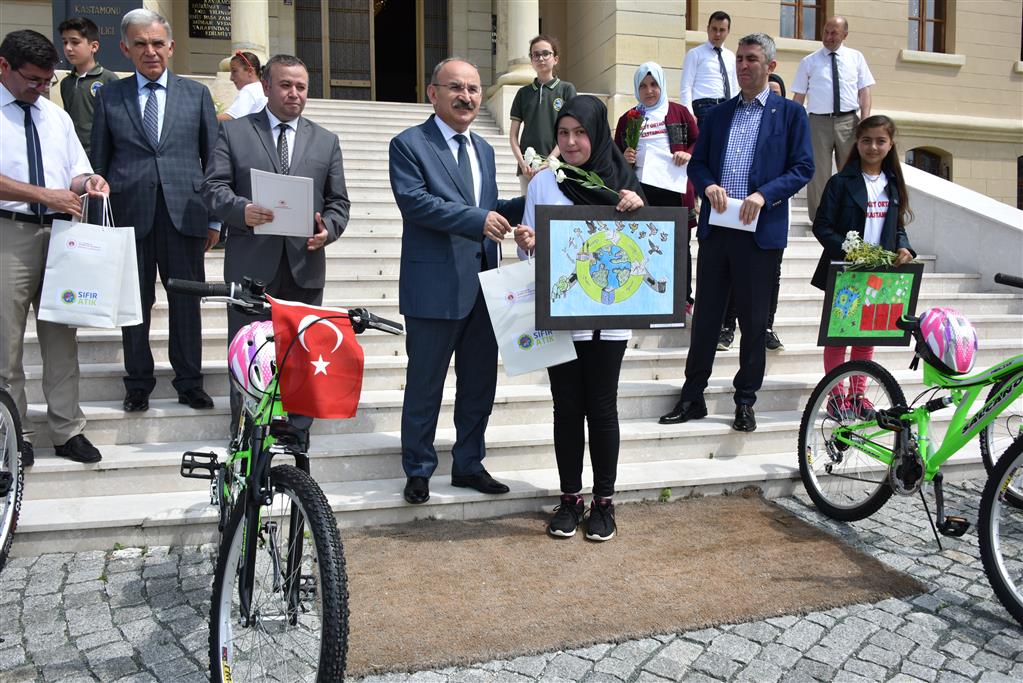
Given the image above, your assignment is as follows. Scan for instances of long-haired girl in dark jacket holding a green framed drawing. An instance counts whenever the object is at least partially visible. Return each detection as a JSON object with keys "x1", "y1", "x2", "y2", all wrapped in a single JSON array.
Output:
[{"x1": 810, "y1": 116, "x2": 916, "y2": 419}]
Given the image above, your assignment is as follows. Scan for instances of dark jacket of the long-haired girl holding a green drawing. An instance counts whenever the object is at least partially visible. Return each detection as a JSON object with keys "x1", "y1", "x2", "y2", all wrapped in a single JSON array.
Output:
[{"x1": 810, "y1": 160, "x2": 917, "y2": 289}]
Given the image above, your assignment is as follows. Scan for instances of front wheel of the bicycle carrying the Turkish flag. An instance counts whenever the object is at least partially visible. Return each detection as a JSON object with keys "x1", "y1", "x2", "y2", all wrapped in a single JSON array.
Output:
[{"x1": 210, "y1": 465, "x2": 348, "y2": 683}]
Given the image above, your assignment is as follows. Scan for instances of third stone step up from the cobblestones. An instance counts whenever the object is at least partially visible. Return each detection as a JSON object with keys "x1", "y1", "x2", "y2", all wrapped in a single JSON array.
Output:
[{"x1": 28, "y1": 368, "x2": 1006, "y2": 447}]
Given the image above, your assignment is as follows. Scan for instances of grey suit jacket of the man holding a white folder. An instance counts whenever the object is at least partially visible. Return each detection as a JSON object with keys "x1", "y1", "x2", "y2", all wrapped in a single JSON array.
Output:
[{"x1": 202, "y1": 109, "x2": 351, "y2": 289}]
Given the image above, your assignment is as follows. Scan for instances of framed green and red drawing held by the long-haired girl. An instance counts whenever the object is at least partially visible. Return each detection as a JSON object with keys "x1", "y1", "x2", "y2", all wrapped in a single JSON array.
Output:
[{"x1": 817, "y1": 263, "x2": 924, "y2": 347}]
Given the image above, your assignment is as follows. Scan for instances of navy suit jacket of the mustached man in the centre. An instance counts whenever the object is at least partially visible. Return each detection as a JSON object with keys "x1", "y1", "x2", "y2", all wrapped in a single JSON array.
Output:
[{"x1": 389, "y1": 116, "x2": 525, "y2": 320}]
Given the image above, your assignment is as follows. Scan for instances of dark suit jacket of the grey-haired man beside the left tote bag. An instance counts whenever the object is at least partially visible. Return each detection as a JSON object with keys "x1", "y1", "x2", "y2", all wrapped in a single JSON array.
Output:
[{"x1": 89, "y1": 72, "x2": 217, "y2": 238}]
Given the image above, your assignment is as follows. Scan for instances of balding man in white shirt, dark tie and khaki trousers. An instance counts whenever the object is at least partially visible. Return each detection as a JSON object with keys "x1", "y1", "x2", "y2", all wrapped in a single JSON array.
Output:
[{"x1": 792, "y1": 16, "x2": 874, "y2": 221}]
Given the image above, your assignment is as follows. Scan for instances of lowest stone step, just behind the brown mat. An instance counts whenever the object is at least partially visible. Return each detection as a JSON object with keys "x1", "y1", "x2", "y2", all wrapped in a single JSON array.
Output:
[{"x1": 12, "y1": 449, "x2": 983, "y2": 556}]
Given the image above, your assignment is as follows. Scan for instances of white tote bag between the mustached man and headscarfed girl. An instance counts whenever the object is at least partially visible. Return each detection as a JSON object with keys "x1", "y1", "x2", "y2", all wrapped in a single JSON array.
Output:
[{"x1": 480, "y1": 259, "x2": 576, "y2": 377}]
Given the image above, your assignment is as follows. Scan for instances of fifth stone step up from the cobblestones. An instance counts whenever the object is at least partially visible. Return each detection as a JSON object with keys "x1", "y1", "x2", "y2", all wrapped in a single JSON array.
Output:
[{"x1": 25, "y1": 312, "x2": 1023, "y2": 366}]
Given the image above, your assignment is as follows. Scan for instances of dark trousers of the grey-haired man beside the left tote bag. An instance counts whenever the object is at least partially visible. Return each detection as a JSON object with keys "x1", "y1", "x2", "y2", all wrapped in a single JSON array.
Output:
[{"x1": 121, "y1": 188, "x2": 206, "y2": 394}]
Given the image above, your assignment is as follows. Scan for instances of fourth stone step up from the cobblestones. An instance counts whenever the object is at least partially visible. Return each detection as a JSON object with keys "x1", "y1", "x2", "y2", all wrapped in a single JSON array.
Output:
[{"x1": 25, "y1": 334, "x2": 1023, "y2": 403}]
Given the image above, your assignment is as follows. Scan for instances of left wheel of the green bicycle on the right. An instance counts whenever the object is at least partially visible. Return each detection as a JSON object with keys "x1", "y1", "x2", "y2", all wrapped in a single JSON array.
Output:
[{"x1": 797, "y1": 361, "x2": 905, "y2": 521}]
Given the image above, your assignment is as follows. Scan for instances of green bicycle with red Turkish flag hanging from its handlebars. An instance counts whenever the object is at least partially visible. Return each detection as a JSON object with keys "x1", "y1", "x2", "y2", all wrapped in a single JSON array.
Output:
[{"x1": 167, "y1": 279, "x2": 402, "y2": 683}]
